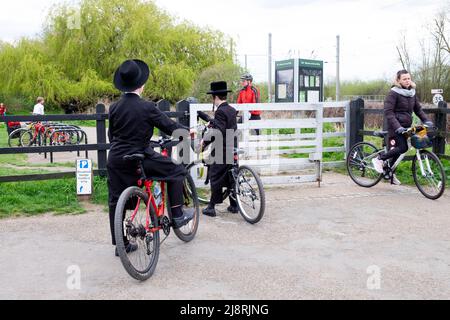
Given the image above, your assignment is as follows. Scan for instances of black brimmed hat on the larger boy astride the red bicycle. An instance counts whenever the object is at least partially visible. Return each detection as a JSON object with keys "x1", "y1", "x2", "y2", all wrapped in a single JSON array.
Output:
[{"x1": 114, "y1": 59, "x2": 150, "y2": 92}]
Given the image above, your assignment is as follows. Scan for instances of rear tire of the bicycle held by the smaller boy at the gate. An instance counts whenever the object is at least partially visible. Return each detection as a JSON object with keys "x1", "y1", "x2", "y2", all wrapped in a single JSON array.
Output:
[{"x1": 235, "y1": 166, "x2": 266, "y2": 224}]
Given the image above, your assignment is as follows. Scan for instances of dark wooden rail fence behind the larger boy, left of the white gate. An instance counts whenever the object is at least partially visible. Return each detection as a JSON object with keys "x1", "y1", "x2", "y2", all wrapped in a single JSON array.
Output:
[{"x1": 0, "y1": 100, "x2": 189, "y2": 183}]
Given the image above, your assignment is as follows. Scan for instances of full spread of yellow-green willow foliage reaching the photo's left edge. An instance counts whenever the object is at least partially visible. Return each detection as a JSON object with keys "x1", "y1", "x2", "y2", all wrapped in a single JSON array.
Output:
[{"x1": 0, "y1": 0, "x2": 237, "y2": 111}]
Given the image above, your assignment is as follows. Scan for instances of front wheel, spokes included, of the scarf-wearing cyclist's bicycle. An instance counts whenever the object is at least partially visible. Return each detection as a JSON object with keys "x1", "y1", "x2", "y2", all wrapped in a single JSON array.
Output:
[{"x1": 412, "y1": 150, "x2": 446, "y2": 200}]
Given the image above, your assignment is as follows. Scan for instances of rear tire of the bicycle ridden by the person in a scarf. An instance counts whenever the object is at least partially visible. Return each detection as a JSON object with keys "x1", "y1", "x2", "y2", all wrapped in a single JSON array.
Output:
[{"x1": 346, "y1": 142, "x2": 383, "y2": 188}]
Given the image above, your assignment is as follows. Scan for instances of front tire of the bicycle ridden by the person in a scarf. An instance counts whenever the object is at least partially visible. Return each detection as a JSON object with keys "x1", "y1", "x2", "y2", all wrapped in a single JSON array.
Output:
[{"x1": 411, "y1": 150, "x2": 447, "y2": 200}]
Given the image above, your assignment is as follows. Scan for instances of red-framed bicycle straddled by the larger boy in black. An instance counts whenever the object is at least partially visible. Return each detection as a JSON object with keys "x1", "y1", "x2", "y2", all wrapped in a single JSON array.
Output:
[{"x1": 115, "y1": 138, "x2": 200, "y2": 281}]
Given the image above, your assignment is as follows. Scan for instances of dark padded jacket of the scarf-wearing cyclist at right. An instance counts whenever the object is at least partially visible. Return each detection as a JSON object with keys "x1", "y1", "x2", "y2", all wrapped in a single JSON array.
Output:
[{"x1": 384, "y1": 90, "x2": 428, "y2": 137}]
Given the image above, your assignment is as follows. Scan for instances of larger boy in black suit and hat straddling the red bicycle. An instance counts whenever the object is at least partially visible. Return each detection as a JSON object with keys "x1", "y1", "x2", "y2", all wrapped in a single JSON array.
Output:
[{"x1": 107, "y1": 60, "x2": 194, "y2": 256}]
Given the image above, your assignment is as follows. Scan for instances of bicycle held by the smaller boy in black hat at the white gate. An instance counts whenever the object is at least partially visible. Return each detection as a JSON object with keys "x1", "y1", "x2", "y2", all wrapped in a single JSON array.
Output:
[{"x1": 187, "y1": 112, "x2": 266, "y2": 224}]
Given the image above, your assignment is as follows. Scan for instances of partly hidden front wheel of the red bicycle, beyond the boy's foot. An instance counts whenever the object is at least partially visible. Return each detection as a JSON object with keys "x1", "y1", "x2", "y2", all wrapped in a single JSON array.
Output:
[{"x1": 168, "y1": 174, "x2": 200, "y2": 242}]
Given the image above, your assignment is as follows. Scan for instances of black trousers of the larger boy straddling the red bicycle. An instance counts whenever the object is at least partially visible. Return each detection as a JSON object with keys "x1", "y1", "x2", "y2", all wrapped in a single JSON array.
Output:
[{"x1": 108, "y1": 153, "x2": 187, "y2": 245}]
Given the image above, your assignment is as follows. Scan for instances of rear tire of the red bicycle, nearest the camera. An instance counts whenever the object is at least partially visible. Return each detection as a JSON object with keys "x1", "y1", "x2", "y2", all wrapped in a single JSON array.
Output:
[{"x1": 114, "y1": 187, "x2": 160, "y2": 281}]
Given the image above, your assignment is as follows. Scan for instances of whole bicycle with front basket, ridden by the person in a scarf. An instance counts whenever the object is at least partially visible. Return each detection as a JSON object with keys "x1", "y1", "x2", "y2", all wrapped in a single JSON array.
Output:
[{"x1": 347, "y1": 125, "x2": 446, "y2": 200}]
